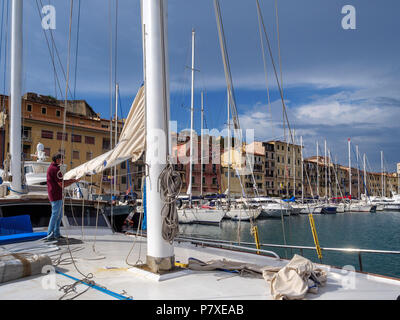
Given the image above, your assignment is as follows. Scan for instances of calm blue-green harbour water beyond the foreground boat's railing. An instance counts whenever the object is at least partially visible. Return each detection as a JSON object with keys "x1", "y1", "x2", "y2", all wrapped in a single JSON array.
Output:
[{"x1": 179, "y1": 211, "x2": 400, "y2": 278}]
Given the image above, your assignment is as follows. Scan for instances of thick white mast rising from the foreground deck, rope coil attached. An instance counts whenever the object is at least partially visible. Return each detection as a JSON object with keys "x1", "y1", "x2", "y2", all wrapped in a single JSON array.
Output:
[{"x1": 141, "y1": 0, "x2": 175, "y2": 272}]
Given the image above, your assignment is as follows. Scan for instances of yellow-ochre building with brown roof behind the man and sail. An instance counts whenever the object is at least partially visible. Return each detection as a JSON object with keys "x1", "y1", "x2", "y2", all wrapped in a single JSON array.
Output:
[{"x1": 0, "y1": 93, "x2": 129, "y2": 193}]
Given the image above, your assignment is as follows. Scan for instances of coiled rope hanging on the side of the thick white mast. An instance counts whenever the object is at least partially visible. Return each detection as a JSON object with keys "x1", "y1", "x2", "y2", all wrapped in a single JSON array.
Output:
[{"x1": 158, "y1": 163, "x2": 182, "y2": 244}]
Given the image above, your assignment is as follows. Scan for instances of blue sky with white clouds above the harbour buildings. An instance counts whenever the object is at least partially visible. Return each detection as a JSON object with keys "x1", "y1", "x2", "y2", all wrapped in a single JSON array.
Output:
[{"x1": 0, "y1": 0, "x2": 400, "y2": 172}]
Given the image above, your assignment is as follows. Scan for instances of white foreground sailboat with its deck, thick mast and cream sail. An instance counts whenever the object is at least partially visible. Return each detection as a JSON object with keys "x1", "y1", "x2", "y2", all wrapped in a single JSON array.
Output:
[{"x1": 0, "y1": 0, "x2": 400, "y2": 302}]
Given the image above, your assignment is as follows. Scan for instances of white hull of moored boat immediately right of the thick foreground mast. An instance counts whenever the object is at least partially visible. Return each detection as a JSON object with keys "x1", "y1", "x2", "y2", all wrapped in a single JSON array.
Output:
[{"x1": 178, "y1": 208, "x2": 225, "y2": 224}]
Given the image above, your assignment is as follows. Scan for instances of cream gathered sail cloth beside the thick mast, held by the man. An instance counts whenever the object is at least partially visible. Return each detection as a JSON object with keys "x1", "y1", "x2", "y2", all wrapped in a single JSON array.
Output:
[{"x1": 64, "y1": 86, "x2": 146, "y2": 180}]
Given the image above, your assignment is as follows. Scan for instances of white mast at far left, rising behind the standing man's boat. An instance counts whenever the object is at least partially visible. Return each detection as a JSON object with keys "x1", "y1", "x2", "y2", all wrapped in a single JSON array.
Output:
[{"x1": 10, "y1": 0, "x2": 23, "y2": 193}]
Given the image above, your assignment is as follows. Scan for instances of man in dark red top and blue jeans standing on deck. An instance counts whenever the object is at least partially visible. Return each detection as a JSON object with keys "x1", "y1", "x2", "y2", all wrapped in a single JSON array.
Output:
[{"x1": 47, "y1": 153, "x2": 79, "y2": 241}]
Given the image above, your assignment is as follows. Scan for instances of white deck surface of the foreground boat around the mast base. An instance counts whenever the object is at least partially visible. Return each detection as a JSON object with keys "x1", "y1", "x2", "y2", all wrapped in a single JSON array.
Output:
[{"x1": 0, "y1": 230, "x2": 400, "y2": 300}]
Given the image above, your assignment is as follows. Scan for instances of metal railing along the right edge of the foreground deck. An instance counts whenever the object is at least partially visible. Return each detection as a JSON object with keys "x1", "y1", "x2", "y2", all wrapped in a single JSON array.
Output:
[{"x1": 176, "y1": 235, "x2": 400, "y2": 271}]
